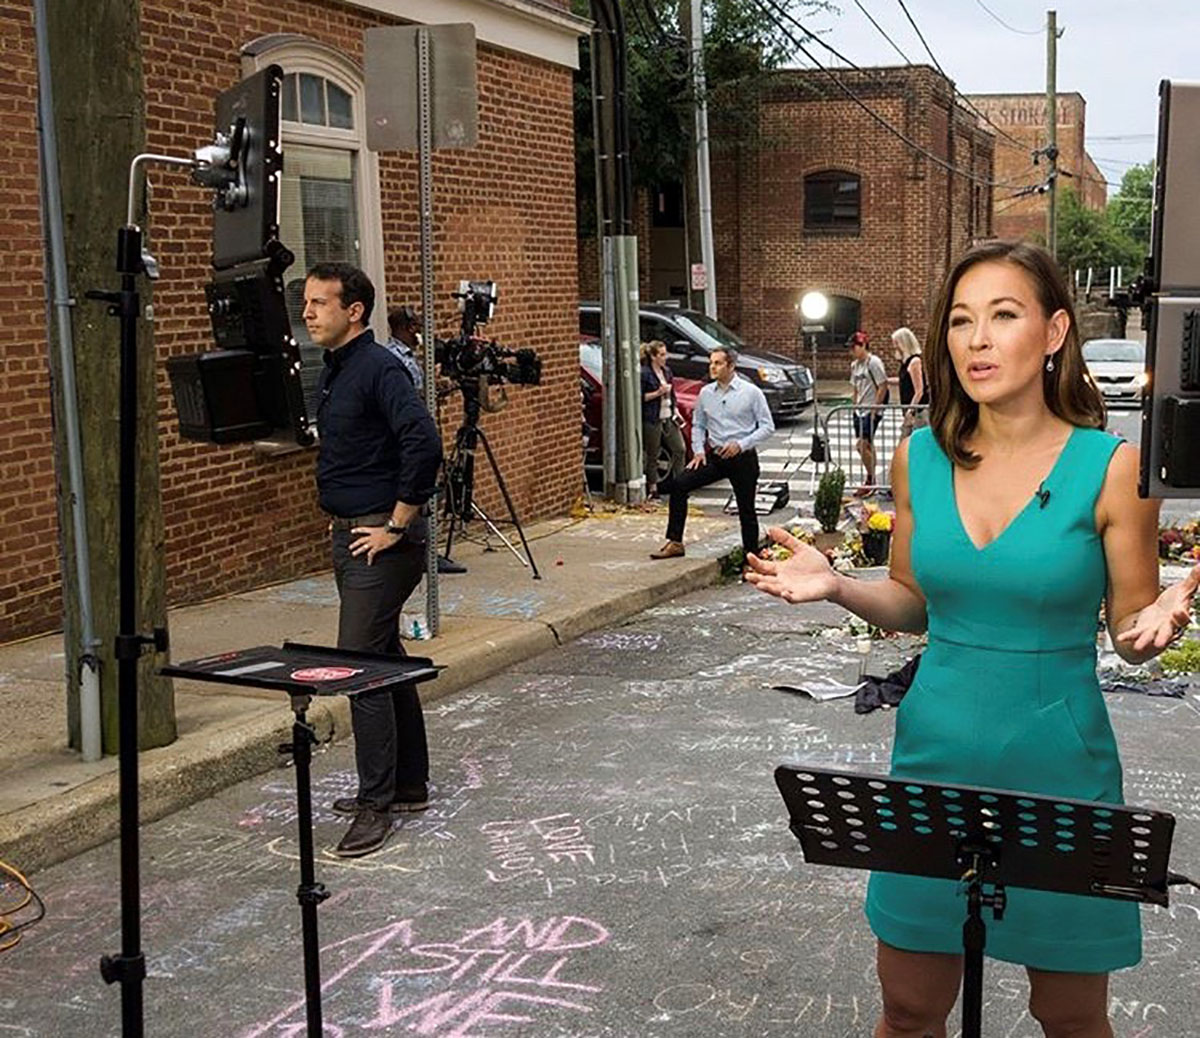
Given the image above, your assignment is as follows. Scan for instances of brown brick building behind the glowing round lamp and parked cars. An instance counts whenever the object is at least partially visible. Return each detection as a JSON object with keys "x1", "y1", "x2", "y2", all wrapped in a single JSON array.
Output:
[{"x1": 713, "y1": 66, "x2": 994, "y2": 378}]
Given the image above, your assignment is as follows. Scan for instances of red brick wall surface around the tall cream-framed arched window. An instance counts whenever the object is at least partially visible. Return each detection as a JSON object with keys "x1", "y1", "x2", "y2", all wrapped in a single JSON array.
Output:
[{"x1": 0, "y1": 0, "x2": 583, "y2": 642}]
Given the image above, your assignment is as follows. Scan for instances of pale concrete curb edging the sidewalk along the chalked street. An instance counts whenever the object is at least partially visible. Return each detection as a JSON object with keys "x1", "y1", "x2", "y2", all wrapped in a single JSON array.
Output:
[{"x1": 0, "y1": 558, "x2": 721, "y2": 874}]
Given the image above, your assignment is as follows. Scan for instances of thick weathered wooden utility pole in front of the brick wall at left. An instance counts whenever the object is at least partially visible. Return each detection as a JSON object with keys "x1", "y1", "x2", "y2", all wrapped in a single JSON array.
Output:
[{"x1": 46, "y1": 0, "x2": 176, "y2": 754}]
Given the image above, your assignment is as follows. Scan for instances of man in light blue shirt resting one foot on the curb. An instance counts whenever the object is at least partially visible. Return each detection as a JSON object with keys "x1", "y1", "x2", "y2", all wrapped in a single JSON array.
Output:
[{"x1": 650, "y1": 347, "x2": 775, "y2": 559}]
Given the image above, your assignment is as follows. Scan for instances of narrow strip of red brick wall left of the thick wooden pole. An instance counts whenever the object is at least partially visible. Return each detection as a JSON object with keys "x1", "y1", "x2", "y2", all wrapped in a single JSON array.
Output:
[{"x1": 0, "y1": 0, "x2": 62, "y2": 642}]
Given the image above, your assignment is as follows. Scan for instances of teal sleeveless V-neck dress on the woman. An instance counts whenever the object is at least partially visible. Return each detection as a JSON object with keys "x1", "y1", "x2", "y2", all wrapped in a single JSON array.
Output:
[{"x1": 866, "y1": 428, "x2": 1141, "y2": 973}]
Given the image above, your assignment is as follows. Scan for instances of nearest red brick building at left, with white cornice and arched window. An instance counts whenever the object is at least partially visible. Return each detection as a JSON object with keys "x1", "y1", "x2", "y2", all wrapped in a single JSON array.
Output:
[{"x1": 0, "y1": 0, "x2": 588, "y2": 642}]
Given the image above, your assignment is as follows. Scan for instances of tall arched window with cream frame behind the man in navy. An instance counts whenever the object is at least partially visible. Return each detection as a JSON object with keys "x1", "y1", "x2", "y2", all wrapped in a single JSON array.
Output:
[{"x1": 242, "y1": 35, "x2": 388, "y2": 415}]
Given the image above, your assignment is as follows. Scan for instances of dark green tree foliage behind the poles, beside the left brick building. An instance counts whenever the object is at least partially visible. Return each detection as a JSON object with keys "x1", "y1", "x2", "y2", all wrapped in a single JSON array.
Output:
[{"x1": 572, "y1": 0, "x2": 832, "y2": 236}]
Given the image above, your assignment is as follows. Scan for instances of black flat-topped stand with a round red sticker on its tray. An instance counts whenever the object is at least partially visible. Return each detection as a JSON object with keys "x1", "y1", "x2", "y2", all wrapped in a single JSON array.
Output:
[{"x1": 162, "y1": 642, "x2": 440, "y2": 1038}]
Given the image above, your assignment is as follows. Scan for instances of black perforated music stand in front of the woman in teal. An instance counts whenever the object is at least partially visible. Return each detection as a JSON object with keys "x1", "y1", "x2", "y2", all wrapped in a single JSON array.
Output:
[{"x1": 775, "y1": 764, "x2": 1190, "y2": 1038}]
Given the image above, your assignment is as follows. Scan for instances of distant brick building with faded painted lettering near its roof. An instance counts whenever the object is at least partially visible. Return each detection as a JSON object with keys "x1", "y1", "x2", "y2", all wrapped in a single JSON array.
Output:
[{"x1": 970, "y1": 94, "x2": 1108, "y2": 240}]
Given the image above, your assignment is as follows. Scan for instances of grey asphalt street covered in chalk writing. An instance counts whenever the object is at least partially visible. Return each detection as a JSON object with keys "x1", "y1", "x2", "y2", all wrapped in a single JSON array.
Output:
[{"x1": 0, "y1": 584, "x2": 1200, "y2": 1038}]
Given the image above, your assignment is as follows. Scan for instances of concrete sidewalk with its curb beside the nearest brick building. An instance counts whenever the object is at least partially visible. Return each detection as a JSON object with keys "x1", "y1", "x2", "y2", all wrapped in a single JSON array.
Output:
[{"x1": 0, "y1": 500, "x2": 739, "y2": 871}]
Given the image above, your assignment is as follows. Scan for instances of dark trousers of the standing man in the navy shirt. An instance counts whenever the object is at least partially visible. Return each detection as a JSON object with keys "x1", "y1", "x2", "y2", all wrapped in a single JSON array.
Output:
[{"x1": 334, "y1": 530, "x2": 430, "y2": 811}]
